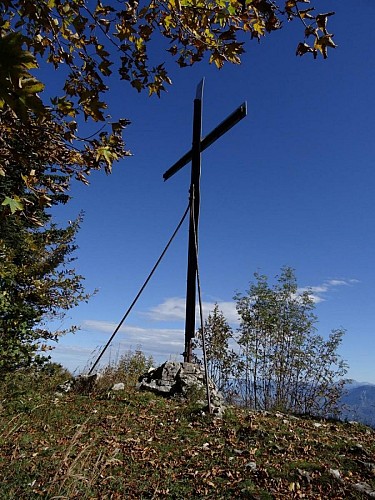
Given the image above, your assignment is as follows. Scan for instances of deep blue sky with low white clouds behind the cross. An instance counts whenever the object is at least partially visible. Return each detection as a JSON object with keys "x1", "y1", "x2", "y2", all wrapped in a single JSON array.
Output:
[{"x1": 47, "y1": 0, "x2": 375, "y2": 383}]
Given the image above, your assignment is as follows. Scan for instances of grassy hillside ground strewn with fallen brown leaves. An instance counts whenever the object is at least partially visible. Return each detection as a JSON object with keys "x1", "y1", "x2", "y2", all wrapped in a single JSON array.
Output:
[{"x1": 0, "y1": 368, "x2": 375, "y2": 499}]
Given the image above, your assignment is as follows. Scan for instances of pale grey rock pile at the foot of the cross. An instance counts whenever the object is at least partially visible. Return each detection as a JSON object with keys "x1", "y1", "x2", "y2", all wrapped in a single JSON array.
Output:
[{"x1": 137, "y1": 361, "x2": 225, "y2": 416}]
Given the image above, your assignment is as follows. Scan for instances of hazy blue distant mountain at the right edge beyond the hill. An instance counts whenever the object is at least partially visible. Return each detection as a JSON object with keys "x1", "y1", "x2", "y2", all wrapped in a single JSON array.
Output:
[{"x1": 340, "y1": 381, "x2": 375, "y2": 428}]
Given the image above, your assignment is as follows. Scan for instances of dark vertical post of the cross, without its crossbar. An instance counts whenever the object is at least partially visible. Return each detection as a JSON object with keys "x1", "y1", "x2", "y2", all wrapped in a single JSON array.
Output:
[{"x1": 184, "y1": 80, "x2": 204, "y2": 363}]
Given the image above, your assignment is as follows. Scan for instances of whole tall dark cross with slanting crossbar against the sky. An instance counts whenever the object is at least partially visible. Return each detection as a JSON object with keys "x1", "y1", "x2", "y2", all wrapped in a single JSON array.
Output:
[{"x1": 163, "y1": 79, "x2": 247, "y2": 363}]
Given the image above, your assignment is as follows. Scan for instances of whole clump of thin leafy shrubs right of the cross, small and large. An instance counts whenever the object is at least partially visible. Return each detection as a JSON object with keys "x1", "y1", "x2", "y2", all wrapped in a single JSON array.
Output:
[{"x1": 196, "y1": 267, "x2": 348, "y2": 417}]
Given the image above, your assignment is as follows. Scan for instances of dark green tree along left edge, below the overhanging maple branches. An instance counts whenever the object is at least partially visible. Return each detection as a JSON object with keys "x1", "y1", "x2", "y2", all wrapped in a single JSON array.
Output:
[{"x1": 0, "y1": 113, "x2": 93, "y2": 373}]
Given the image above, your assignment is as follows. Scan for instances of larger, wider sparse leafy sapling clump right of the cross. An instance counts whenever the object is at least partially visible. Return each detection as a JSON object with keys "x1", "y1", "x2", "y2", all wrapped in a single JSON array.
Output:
[{"x1": 235, "y1": 267, "x2": 347, "y2": 415}]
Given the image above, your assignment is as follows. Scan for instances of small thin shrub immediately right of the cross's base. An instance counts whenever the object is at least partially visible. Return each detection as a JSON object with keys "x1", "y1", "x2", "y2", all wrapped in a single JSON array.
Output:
[{"x1": 194, "y1": 304, "x2": 237, "y2": 393}]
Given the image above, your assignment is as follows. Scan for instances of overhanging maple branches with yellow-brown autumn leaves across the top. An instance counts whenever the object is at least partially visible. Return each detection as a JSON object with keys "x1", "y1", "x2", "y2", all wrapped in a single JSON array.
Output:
[{"x1": 0, "y1": 0, "x2": 336, "y2": 225}]
